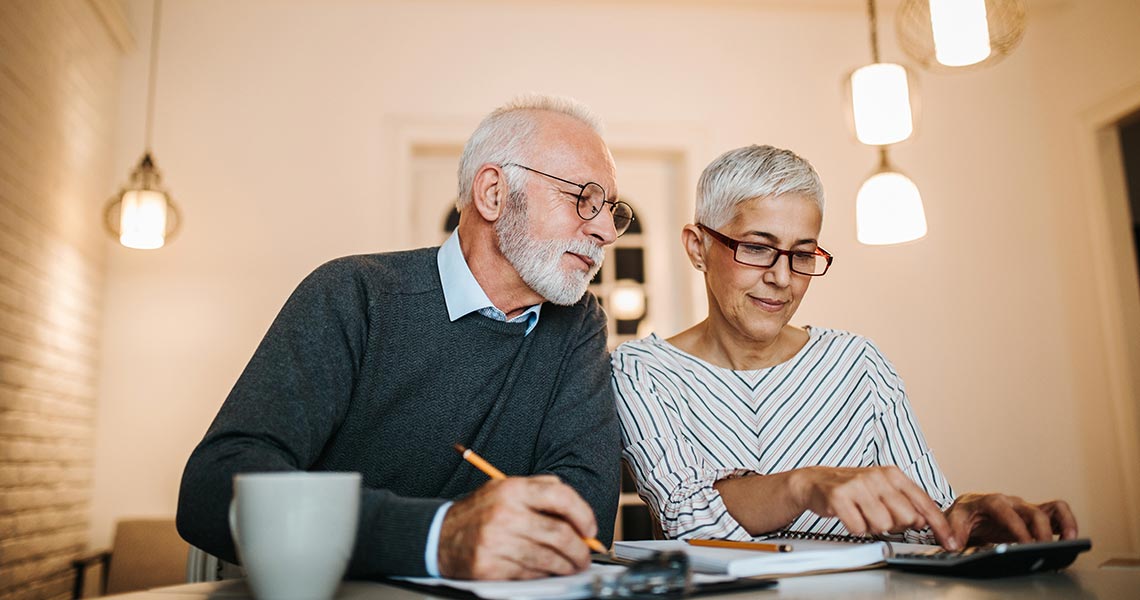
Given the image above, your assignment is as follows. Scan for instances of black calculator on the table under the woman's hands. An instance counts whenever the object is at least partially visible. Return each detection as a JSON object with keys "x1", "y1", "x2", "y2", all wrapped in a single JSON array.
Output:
[{"x1": 887, "y1": 538, "x2": 1092, "y2": 577}]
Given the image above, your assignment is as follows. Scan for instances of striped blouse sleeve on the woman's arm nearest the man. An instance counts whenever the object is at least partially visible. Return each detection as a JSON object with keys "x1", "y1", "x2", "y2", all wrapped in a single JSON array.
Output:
[{"x1": 612, "y1": 348, "x2": 752, "y2": 540}]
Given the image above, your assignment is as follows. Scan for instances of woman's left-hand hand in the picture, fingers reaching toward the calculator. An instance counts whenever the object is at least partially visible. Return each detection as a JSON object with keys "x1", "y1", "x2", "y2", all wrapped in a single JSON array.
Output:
[{"x1": 791, "y1": 467, "x2": 966, "y2": 550}]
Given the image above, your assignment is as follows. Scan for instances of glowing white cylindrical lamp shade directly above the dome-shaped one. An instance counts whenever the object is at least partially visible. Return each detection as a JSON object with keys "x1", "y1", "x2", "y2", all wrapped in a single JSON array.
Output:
[{"x1": 850, "y1": 63, "x2": 914, "y2": 146}]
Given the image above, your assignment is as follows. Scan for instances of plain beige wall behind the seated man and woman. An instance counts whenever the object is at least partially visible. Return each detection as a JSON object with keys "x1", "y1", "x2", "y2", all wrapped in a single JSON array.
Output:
[{"x1": 92, "y1": 0, "x2": 1140, "y2": 568}]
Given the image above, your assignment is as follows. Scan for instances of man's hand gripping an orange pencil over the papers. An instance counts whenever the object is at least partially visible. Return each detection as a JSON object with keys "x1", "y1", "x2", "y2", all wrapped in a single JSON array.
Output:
[{"x1": 439, "y1": 475, "x2": 597, "y2": 579}]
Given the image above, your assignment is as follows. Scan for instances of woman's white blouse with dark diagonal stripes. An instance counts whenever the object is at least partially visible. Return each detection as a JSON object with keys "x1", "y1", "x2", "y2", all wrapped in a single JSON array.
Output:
[{"x1": 612, "y1": 327, "x2": 954, "y2": 542}]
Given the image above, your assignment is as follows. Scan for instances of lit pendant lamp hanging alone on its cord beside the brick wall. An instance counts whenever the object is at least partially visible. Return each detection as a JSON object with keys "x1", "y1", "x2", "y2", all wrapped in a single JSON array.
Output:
[{"x1": 103, "y1": 0, "x2": 181, "y2": 250}]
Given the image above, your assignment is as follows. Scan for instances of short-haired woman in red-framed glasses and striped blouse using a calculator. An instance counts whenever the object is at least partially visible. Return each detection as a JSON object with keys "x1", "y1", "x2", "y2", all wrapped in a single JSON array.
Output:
[{"x1": 613, "y1": 146, "x2": 1077, "y2": 550}]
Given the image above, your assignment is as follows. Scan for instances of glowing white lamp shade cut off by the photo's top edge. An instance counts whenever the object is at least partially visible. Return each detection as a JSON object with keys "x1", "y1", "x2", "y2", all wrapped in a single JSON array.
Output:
[{"x1": 930, "y1": 0, "x2": 991, "y2": 66}]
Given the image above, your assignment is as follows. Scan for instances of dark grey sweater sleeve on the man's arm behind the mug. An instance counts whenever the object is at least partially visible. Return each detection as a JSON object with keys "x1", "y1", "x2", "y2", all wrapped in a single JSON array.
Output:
[{"x1": 177, "y1": 260, "x2": 443, "y2": 576}]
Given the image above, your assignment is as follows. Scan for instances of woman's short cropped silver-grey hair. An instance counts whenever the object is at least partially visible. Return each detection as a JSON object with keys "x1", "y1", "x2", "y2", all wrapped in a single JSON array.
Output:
[{"x1": 697, "y1": 145, "x2": 823, "y2": 229}]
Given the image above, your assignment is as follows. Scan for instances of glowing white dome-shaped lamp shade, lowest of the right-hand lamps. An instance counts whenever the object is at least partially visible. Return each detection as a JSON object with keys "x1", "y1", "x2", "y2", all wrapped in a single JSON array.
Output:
[{"x1": 855, "y1": 171, "x2": 927, "y2": 245}]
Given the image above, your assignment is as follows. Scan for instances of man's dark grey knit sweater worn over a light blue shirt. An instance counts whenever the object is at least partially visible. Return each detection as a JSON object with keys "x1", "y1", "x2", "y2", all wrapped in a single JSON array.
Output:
[{"x1": 178, "y1": 249, "x2": 621, "y2": 577}]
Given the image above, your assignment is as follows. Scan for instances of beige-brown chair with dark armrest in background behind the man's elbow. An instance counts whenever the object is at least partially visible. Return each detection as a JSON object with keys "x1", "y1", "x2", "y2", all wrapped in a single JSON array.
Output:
[{"x1": 72, "y1": 519, "x2": 190, "y2": 598}]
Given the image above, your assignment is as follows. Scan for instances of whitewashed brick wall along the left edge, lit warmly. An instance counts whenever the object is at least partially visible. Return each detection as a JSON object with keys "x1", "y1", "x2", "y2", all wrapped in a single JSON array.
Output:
[{"x1": 0, "y1": 0, "x2": 130, "y2": 599}]
